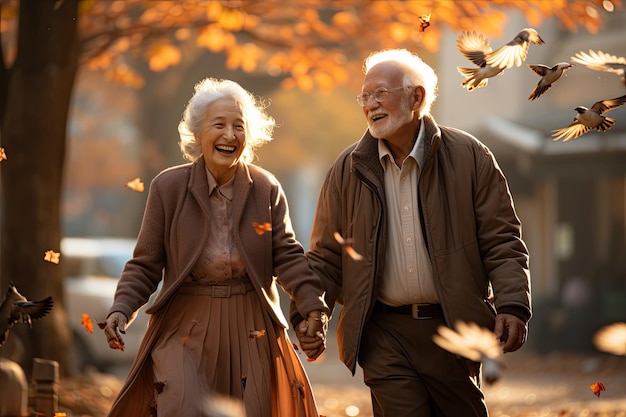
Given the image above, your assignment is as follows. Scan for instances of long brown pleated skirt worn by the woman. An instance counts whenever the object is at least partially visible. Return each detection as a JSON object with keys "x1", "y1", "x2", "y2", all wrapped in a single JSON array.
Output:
[{"x1": 151, "y1": 282, "x2": 319, "y2": 417}]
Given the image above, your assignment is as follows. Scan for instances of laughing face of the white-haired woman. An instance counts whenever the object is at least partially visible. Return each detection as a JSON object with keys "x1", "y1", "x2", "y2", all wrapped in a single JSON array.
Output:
[{"x1": 197, "y1": 97, "x2": 246, "y2": 185}]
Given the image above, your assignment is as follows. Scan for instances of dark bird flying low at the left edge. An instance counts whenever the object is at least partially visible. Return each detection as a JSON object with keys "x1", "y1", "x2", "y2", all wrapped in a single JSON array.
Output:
[{"x1": 0, "y1": 282, "x2": 53, "y2": 346}]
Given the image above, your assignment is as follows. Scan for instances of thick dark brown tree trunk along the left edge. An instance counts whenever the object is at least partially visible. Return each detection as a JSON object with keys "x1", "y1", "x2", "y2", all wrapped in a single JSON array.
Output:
[{"x1": 0, "y1": 0, "x2": 79, "y2": 376}]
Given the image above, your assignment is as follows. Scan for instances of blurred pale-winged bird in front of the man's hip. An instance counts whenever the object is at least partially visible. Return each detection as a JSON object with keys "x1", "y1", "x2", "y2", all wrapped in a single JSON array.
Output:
[{"x1": 433, "y1": 320, "x2": 504, "y2": 384}]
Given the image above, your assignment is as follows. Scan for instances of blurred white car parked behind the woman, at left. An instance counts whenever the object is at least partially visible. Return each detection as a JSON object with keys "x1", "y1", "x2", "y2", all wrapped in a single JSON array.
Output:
[{"x1": 60, "y1": 237, "x2": 148, "y2": 371}]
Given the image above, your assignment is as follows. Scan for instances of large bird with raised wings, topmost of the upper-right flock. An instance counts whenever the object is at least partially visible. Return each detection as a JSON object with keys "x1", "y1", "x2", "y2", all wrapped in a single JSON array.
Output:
[{"x1": 456, "y1": 28, "x2": 544, "y2": 91}]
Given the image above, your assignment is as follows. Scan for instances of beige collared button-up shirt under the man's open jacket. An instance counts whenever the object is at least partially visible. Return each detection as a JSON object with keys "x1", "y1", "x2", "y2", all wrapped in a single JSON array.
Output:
[{"x1": 378, "y1": 120, "x2": 439, "y2": 306}]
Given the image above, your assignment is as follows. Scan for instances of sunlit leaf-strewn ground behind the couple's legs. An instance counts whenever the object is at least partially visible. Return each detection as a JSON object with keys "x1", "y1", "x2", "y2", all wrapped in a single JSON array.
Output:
[{"x1": 58, "y1": 353, "x2": 626, "y2": 417}]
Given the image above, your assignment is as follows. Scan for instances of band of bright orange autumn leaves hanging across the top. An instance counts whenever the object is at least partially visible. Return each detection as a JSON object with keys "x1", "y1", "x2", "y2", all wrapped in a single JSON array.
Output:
[{"x1": 0, "y1": 0, "x2": 622, "y2": 91}]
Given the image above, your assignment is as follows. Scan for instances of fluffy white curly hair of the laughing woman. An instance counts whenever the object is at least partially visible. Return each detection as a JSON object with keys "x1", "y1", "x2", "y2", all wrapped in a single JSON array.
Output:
[{"x1": 178, "y1": 78, "x2": 276, "y2": 163}]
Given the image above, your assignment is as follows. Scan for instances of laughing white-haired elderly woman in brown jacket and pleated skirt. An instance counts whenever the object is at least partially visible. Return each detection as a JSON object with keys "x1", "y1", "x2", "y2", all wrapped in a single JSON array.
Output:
[{"x1": 104, "y1": 78, "x2": 328, "y2": 417}]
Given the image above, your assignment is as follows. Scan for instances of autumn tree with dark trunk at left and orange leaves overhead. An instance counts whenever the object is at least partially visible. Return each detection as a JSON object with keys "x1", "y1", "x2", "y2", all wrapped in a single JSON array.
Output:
[{"x1": 0, "y1": 0, "x2": 621, "y2": 375}]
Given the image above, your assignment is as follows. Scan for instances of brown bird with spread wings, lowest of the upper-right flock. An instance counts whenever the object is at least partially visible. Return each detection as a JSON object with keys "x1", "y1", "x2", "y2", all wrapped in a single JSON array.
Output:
[{"x1": 552, "y1": 95, "x2": 626, "y2": 142}]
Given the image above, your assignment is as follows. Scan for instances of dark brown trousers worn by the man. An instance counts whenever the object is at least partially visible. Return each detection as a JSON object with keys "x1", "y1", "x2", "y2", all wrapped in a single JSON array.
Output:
[{"x1": 359, "y1": 312, "x2": 488, "y2": 417}]
